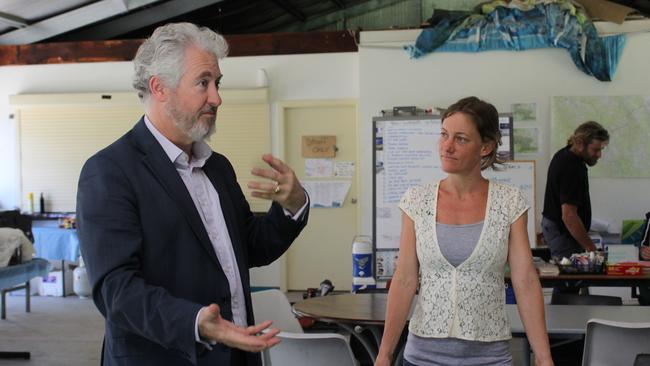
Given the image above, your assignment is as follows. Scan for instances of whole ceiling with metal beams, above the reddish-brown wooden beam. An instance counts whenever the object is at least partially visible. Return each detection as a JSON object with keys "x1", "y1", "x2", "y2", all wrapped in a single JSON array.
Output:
[{"x1": 0, "y1": 0, "x2": 650, "y2": 44}]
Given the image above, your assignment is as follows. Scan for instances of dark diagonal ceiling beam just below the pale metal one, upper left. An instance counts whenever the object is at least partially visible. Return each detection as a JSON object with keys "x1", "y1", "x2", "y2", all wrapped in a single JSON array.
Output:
[{"x1": 54, "y1": 0, "x2": 229, "y2": 41}]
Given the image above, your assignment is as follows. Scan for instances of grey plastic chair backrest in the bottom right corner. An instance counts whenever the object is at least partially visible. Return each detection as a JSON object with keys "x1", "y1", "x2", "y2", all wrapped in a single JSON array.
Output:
[{"x1": 582, "y1": 319, "x2": 650, "y2": 366}]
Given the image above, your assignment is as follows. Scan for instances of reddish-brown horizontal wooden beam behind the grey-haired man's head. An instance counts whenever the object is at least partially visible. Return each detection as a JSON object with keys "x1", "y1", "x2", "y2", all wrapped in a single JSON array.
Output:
[{"x1": 0, "y1": 31, "x2": 358, "y2": 66}]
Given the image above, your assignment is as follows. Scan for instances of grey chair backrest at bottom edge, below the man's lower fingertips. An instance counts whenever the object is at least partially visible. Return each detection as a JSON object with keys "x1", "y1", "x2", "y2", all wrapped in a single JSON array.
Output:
[{"x1": 265, "y1": 332, "x2": 357, "y2": 366}]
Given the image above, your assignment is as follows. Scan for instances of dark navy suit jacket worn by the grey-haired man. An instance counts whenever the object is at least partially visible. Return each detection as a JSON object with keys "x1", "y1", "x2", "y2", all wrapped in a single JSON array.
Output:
[{"x1": 77, "y1": 119, "x2": 307, "y2": 366}]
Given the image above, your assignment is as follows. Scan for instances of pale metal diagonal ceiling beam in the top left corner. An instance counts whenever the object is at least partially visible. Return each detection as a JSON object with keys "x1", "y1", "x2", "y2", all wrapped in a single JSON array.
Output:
[{"x1": 0, "y1": 0, "x2": 165, "y2": 44}]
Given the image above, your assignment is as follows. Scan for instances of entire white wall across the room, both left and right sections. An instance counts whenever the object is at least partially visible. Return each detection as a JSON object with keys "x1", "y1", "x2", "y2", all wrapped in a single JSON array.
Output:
[{"x1": 0, "y1": 31, "x2": 650, "y2": 285}]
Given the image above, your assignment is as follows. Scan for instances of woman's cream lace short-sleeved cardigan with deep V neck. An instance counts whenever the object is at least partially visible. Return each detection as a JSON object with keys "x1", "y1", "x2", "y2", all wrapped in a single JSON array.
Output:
[{"x1": 399, "y1": 181, "x2": 529, "y2": 341}]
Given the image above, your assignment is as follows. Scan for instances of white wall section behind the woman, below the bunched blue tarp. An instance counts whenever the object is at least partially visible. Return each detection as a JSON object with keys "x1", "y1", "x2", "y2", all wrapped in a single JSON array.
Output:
[{"x1": 359, "y1": 31, "x2": 650, "y2": 234}]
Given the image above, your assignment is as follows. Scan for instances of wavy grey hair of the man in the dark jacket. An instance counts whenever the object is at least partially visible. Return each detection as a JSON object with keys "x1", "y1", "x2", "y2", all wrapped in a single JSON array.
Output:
[{"x1": 133, "y1": 23, "x2": 228, "y2": 104}]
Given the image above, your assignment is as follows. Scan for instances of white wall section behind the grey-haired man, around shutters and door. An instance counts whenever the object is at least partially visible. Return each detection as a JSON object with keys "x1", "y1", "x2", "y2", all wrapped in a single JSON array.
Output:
[{"x1": 0, "y1": 53, "x2": 359, "y2": 286}]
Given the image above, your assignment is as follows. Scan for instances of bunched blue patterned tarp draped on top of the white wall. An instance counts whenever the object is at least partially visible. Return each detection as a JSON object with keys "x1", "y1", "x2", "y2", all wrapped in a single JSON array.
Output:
[{"x1": 405, "y1": 0, "x2": 625, "y2": 81}]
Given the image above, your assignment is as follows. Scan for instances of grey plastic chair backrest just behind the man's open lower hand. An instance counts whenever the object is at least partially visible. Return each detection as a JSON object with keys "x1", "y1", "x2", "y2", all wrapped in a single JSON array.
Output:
[{"x1": 251, "y1": 289, "x2": 303, "y2": 333}]
